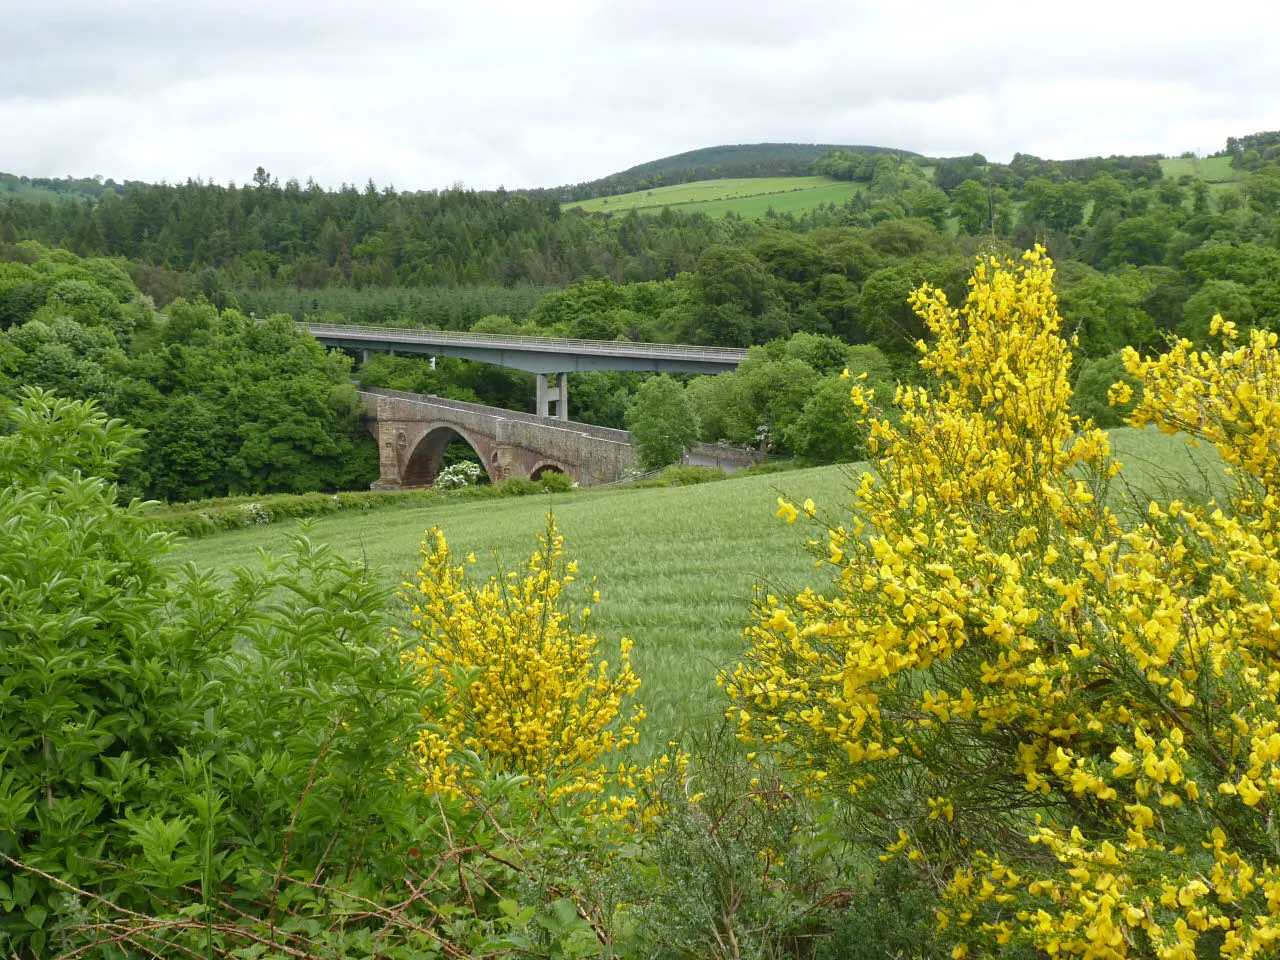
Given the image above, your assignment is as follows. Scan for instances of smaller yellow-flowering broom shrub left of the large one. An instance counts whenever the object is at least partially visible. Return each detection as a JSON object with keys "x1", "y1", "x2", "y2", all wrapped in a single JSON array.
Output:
[{"x1": 406, "y1": 520, "x2": 644, "y2": 812}]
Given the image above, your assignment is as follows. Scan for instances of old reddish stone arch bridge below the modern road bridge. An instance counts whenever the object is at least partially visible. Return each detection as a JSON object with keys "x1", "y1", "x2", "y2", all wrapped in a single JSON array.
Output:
[{"x1": 360, "y1": 389, "x2": 760, "y2": 490}]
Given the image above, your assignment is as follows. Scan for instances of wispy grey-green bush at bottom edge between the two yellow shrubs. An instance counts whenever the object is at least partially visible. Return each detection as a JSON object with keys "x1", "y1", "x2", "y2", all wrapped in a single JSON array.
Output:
[{"x1": 611, "y1": 731, "x2": 948, "y2": 960}]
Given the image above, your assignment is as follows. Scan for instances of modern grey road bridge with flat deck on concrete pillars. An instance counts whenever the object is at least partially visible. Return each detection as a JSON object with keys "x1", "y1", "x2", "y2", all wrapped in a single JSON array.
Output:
[{"x1": 311, "y1": 323, "x2": 746, "y2": 420}]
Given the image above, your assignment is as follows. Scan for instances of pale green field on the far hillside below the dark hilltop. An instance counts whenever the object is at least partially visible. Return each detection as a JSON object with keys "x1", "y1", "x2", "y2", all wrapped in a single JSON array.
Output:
[{"x1": 563, "y1": 177, "x2": 861, "y2": 218}]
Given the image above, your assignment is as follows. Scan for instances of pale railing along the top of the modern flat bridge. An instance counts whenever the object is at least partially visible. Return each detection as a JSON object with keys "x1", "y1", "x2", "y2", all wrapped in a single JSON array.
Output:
[{"x1": 298, "y1": 321, "x2": 746, "y2": 364}]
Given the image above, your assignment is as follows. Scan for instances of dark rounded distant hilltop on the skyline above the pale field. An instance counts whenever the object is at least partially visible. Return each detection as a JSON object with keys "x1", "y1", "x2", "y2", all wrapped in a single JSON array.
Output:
[{"x1": 521, "y1": 143, "x2": 918, "y2": 204}]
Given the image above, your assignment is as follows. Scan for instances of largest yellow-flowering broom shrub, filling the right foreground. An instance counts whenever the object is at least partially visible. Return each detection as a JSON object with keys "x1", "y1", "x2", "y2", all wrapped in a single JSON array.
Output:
[{"x1": 721, "y1": 248, "x2": 1280, "y2": 960}]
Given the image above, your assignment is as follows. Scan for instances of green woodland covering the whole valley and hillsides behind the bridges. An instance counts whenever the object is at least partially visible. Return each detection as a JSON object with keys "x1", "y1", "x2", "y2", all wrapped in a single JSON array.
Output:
[{"x1": 0, "y1": 133, "x2": 1280, "y2": 499}]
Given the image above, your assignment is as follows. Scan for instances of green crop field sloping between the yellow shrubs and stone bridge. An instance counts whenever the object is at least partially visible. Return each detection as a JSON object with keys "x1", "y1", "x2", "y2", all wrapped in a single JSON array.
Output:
[{"x1": 177, "y1": 429, "x2": 1220, "y2": 749}]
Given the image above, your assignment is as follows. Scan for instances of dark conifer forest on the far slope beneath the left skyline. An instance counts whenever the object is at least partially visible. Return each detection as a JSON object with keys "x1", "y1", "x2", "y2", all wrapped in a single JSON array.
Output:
[{"x1": 0, "y1": 172, "x2": 723, "y2": 288}]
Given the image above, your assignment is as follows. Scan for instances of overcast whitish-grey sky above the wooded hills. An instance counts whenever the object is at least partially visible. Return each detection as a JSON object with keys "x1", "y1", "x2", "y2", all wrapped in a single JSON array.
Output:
[{"x1": 0, "y1": 0, "x2": 1280, "y2": 189}]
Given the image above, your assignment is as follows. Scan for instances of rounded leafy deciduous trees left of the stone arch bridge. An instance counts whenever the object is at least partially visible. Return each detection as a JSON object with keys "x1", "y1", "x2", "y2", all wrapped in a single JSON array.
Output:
[{"x1": 0, "y1": 244, "x2": 375, "y2": 500}]
